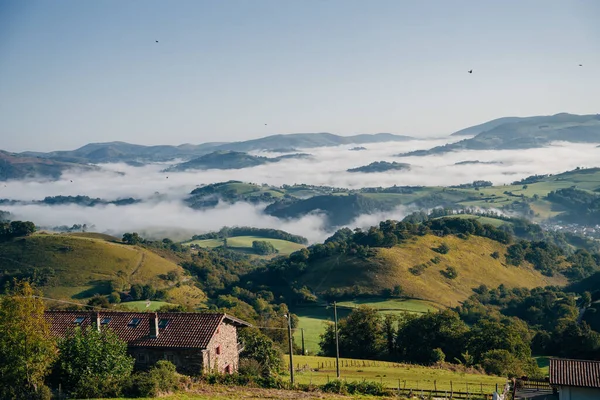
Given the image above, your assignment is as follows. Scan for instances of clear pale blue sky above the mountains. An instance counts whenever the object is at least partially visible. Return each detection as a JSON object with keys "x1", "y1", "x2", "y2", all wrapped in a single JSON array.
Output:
[{"x1": 0, "y1": 0, "x2": 600, "y2": 151}]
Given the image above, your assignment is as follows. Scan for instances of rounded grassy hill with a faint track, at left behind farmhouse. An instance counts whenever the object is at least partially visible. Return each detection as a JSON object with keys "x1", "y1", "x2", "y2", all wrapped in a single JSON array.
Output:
[{"x1": 0, "y1": 234, "x2": 181, "y2": 299}]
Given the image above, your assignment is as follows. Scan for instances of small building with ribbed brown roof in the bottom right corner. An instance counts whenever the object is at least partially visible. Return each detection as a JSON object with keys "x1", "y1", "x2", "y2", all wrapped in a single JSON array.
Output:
[{"x1": 550, "y1": 358, "x2": 600, "y2": 400}]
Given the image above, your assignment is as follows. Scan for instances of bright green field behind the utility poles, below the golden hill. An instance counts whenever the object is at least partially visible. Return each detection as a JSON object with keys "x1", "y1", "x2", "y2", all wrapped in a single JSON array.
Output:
[{"x1": 292, "y1": 297, "x2": 439, "y2": 354}]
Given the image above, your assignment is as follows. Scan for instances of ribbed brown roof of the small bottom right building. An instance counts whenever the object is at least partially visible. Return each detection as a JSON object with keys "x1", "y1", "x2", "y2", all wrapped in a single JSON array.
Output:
[{"x1": 550, "y1": 358, "x2": 600, "y2": 388}]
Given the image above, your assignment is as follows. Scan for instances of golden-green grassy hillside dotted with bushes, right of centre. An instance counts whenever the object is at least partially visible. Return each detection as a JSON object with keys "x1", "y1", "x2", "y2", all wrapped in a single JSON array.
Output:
[{"x1": 301, "y1": 235, "x2": 566, "y2": 306}]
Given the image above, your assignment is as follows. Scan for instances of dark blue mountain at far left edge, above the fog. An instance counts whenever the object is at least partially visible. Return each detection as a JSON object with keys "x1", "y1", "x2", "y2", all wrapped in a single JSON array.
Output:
[{"x1": 0, "y1": 150, "x2": 94, "y2": 181}]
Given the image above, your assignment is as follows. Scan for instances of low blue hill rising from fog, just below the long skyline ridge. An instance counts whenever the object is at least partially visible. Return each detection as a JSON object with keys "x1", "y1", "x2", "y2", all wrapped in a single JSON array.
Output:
[{"x1": 167, "y1": 151, "x2": 310, "y2": 171}]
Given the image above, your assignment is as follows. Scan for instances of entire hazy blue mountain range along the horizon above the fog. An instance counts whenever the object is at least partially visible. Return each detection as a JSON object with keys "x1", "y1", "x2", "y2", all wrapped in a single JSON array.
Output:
[{"x1": 0, "y1": 113, "x2": 600, "y2": 181}]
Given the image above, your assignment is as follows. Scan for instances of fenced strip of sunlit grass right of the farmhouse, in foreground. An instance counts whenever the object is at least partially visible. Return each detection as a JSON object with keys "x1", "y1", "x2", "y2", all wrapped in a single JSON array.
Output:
[{"x1": 285, "y1": 356, "x2": 506, "y2": 393}]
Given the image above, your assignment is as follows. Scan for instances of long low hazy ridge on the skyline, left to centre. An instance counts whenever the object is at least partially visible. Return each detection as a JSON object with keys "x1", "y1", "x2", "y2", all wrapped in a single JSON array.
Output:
[{"x1": 21, "y1": 133, "x2": 412, "y2": 164}]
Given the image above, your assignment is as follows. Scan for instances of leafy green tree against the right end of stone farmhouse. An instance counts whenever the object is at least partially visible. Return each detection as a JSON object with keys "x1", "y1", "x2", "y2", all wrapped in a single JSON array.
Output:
[{"x1": 239, "y1": 329, "x2": 283, "y2": 376}]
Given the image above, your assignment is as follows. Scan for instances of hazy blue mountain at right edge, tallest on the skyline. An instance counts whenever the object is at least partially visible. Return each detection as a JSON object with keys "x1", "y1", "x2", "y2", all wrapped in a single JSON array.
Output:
[{"x1": 399, "y1": 113, "x2": 600, "y2": 156}]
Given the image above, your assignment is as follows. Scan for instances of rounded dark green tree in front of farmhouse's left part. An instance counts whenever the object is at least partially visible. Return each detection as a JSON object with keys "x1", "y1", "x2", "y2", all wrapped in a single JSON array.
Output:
[{"x1": 55, "y1": 326, "x2": 134, "y2": 398}]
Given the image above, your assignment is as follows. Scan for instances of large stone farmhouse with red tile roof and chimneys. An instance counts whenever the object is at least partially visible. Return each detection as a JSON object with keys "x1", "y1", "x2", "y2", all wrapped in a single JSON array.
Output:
[{"x1": 45, "y1": 311, "x2": 250, "y2": 375}]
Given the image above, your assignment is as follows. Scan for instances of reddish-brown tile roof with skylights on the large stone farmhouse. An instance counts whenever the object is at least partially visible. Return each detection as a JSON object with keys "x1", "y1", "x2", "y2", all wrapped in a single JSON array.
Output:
[{"x1": 45, "y1": 311, "x2": 250, "y2": 349}]
